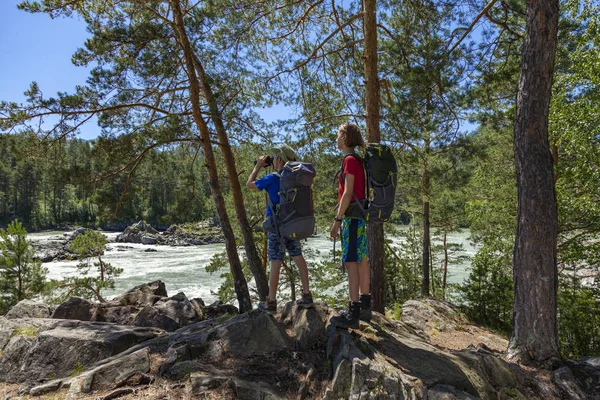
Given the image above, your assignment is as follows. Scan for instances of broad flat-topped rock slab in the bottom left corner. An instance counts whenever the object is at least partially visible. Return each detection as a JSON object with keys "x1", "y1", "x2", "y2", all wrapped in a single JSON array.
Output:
[{"x1": 0, "y1": 318, "x2": 162, "y2": 383}]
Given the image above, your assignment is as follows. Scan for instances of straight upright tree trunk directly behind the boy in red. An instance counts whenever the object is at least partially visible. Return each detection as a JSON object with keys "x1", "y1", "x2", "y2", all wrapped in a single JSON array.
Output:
[{"x1": 363, "y1": 0, "x2": 385, "y2": 313}]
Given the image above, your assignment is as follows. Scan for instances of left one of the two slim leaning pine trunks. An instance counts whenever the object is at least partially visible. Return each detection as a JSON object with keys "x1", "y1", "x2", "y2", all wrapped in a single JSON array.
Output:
[{"x1": 171, "y1": 0, "x2": 252, "y2": 313}]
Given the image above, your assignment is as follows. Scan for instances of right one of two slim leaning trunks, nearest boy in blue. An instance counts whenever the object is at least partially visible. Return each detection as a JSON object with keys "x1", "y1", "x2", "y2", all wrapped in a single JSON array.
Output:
[{"x1": 194, "y1": 56, "x2": 270, "y2": 301}]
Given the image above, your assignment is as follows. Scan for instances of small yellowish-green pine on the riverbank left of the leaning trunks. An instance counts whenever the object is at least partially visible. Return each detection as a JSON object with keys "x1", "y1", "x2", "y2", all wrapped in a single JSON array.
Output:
[{"x1": 53, "y1": 230, "x2": 123, "y2": 302}]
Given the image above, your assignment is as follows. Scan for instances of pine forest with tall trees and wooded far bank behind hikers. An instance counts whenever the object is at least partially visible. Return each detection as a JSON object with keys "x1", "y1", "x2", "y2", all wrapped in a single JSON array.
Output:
[{"x1": 0, "y1": 0, "x2": 600, "y2": 364}]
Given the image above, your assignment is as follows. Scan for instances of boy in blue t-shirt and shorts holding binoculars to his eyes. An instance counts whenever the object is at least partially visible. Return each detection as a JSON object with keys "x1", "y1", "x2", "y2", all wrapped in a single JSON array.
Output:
[{"x1": 246, "y1": 144, "x2": 313, "y2": 314}]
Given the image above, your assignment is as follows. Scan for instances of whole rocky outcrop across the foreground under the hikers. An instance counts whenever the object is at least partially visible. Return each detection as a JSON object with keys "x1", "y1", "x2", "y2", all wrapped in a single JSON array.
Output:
[{"x1": 0, "y1": 290, "x2": 600, "y2": 400}]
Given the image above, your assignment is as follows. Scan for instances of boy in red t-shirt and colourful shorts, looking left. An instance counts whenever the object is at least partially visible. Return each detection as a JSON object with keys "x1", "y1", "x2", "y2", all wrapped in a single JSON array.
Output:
[{"x1": 330, "y1": 123, "x2": 371, "y2": 328}]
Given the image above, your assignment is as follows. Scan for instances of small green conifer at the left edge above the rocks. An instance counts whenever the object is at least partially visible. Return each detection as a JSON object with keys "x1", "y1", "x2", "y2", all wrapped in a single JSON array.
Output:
[{"x1": 0, "y1": 220, "x2": 48, "y2": 314}]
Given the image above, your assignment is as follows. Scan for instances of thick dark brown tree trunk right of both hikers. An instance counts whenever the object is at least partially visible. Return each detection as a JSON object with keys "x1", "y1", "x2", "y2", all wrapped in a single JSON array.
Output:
[{"x1": 508, "y1": 0, "x2": 561, "y2": 368}]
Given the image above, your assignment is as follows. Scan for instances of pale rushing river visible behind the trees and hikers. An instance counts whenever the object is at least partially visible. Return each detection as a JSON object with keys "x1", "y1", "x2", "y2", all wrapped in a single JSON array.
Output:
[{"x1": 29, "y1": 229, "x2": 477, "y2": 304}]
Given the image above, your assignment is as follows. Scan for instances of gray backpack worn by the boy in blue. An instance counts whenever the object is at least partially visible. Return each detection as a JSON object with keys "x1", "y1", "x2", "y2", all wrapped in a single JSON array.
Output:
[{"x1": 269, "y1": 161, "x2": 316, "y2": 240}]
